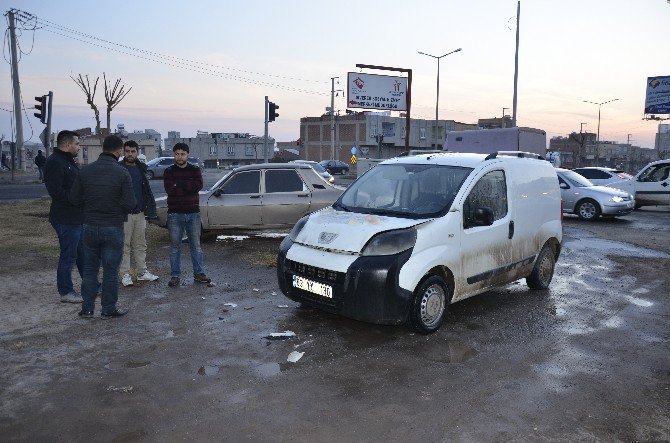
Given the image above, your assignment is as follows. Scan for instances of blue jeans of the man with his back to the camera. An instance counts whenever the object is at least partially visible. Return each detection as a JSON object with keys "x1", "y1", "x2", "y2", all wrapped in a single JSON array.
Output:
[{"x1": 81, "y1": 224, "x2": 123, "y2": 314}]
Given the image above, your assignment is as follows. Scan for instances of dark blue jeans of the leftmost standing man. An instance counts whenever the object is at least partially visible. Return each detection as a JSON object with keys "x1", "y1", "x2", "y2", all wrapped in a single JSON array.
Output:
[{"x1": 51, "y1": 223, "x2": 84, "y2": 295}]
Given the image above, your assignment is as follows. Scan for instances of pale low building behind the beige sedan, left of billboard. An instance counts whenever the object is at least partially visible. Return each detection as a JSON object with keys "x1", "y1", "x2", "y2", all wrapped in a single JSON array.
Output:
[{"x1": 164, "y1": 131, "x2": 275, "y2": 168}]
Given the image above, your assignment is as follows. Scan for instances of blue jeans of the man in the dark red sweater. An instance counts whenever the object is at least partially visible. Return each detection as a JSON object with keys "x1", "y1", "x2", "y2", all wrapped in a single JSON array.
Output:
[{"x1": 168, "y1": 212, "x2": 205, "y2": 277}]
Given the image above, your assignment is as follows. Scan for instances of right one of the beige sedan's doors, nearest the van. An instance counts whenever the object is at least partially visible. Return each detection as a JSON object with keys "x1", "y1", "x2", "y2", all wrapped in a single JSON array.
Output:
[{"x1": 263, "y1": 168, "x2": 312, "y2": 226}]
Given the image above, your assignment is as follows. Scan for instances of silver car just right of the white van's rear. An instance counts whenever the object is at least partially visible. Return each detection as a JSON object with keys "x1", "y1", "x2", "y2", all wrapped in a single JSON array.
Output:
[{"x1": 556, "y1": 168, "x2": 635, "y2": 220}]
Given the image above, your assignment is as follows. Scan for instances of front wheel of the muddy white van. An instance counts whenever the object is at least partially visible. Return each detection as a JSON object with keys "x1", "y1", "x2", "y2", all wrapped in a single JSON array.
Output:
[{"x1": 408, "y1": 275, "x2": 452, "y2": 334}]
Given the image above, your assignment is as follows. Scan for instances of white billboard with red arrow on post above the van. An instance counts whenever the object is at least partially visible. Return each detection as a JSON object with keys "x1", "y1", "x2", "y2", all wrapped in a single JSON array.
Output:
[{"x1": 347, "y1": 72, "x2": 407, "y2": 111}]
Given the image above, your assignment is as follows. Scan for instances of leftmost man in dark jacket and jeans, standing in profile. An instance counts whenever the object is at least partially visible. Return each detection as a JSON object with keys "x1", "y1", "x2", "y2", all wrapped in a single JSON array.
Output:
[{"x1": 44, "y1": 131, "x2": 84, "y2": 303}]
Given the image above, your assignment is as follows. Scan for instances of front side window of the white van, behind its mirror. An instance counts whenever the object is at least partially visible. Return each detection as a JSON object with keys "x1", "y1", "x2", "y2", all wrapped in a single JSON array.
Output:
[{"x1": 463, "y1": 171, "x2": 507, "y2": 228}]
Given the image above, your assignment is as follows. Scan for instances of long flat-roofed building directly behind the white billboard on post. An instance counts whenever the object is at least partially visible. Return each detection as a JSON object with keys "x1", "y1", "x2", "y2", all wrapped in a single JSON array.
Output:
[{"x1": 300, "y1": 111, "x2": 478, "y2": 161}]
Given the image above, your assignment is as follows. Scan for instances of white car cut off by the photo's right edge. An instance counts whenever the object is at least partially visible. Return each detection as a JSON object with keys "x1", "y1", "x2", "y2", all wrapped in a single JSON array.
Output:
[{"x1": 608, "y1": 159, "x2": 670, "y2": 208}]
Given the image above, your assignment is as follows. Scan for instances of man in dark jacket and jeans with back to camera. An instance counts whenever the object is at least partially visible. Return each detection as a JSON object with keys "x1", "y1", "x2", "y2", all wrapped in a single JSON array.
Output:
[{"x1": 70, "y1": 135, "x2": 136, "y2": 319}]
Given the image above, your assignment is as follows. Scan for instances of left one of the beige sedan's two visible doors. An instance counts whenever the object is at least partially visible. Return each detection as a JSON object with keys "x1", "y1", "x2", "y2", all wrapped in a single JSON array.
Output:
[{"x1": 207, "y1": 171, "x2": 263, "y2": 228}]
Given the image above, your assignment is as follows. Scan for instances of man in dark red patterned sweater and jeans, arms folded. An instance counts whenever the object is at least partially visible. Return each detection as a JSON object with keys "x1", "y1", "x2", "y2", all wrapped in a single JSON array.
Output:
[{"x1": 163, "y1": 143, "x2": 211, "y2": 287}]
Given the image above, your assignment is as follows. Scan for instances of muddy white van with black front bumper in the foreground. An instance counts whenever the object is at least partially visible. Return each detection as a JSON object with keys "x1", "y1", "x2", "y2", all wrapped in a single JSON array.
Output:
[{"x1": 277, "y1": 152, "x2": 562, "y2": 333}]
